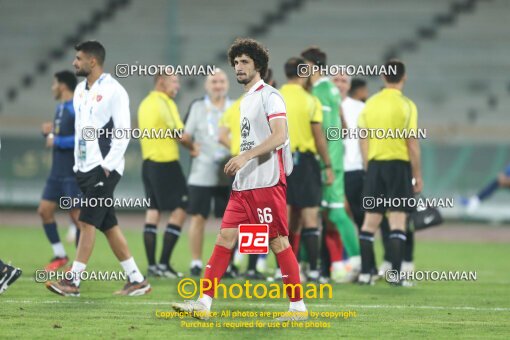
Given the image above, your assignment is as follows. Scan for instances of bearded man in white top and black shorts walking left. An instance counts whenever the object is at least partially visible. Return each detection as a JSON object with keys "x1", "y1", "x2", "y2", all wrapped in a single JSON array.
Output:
[{"x1": 46, "y1": 41, "x2": 151, "y2": 296}]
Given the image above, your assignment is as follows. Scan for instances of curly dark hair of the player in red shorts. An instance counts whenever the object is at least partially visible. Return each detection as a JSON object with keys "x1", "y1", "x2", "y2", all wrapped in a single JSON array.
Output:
[{"x1": 228, "y1": 38, "x2": 269, "y2": 78}]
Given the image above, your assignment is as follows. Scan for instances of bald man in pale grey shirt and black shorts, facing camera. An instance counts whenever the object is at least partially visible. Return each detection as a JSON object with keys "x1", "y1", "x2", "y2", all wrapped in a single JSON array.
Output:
[{"x1": 183, "y1": 69, "x2": 232, "y2": 277}]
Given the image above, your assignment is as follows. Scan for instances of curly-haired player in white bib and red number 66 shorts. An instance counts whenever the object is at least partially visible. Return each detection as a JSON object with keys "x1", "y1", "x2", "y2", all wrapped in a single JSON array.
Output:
[{"x1": 172, "y1": 39, "x2": 308, "y2": 321}]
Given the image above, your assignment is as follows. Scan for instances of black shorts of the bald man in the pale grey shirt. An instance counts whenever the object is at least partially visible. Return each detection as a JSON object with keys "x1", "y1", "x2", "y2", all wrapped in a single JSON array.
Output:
[{"x1": 188, "y1": 185, "x2": 230, "y2": 218}]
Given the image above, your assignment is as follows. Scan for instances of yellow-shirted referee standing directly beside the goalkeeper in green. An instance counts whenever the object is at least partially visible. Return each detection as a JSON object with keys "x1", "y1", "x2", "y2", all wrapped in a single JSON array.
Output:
[{"x1": 280, "y1": 58, "x2": 334, "y2": 281}]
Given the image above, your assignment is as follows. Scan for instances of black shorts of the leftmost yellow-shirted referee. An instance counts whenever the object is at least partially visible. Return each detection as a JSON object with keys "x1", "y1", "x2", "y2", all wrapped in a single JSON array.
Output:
[{"x1": 142, "y1": 159, "x2": 188, "y2": 211}]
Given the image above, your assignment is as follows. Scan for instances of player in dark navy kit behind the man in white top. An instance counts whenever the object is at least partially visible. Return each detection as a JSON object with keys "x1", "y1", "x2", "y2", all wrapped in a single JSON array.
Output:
[{"x1": 37, "y1": 71, "x2": 80, "y2": 271}]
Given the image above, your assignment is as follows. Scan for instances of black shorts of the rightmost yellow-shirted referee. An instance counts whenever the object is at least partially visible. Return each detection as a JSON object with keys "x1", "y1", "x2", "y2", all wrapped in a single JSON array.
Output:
[{"x1": 363, "y1": 160, "x2": 414, "y2": 213}]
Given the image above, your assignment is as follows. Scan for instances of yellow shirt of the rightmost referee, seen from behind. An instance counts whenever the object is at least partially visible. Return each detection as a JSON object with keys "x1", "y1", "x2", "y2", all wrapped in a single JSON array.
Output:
[{"x1": 358, "y1": 88, "x2": 418, "y2": 161}]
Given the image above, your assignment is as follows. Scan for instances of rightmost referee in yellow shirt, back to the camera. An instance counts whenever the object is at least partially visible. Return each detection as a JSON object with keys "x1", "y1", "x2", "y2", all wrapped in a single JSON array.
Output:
[{"x1": 358, "y1": 60, "x2": 423, "y2": 286}]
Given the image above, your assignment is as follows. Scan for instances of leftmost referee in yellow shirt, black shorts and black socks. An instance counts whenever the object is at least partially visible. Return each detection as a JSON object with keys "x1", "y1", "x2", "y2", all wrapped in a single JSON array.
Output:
[{"x1": 138, "y1": 75, "x2": 193, "y2": 278}]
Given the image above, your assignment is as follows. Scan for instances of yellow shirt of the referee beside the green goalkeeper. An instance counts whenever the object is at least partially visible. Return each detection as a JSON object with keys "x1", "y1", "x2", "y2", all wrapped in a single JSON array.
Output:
[{"x1": 280, "y1": 84, "x2": 322, "y2": 154}]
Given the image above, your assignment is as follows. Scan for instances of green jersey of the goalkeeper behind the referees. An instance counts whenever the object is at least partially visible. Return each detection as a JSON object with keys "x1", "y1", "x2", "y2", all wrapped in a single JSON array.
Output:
[{"x1": 312, "y1": 77, "x2": 344, "y2": 171}]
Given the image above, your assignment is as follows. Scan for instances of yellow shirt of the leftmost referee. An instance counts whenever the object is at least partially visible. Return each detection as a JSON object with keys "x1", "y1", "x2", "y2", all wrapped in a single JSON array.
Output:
[{"x1": 138, "y1": 91, "x2": 184, "y2": 162}]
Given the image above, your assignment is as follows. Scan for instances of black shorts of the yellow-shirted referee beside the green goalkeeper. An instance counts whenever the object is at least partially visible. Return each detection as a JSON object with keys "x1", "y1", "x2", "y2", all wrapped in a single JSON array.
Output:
[{"x1": 287, "y1": 152, "x2": 322, "y2": 208}]
